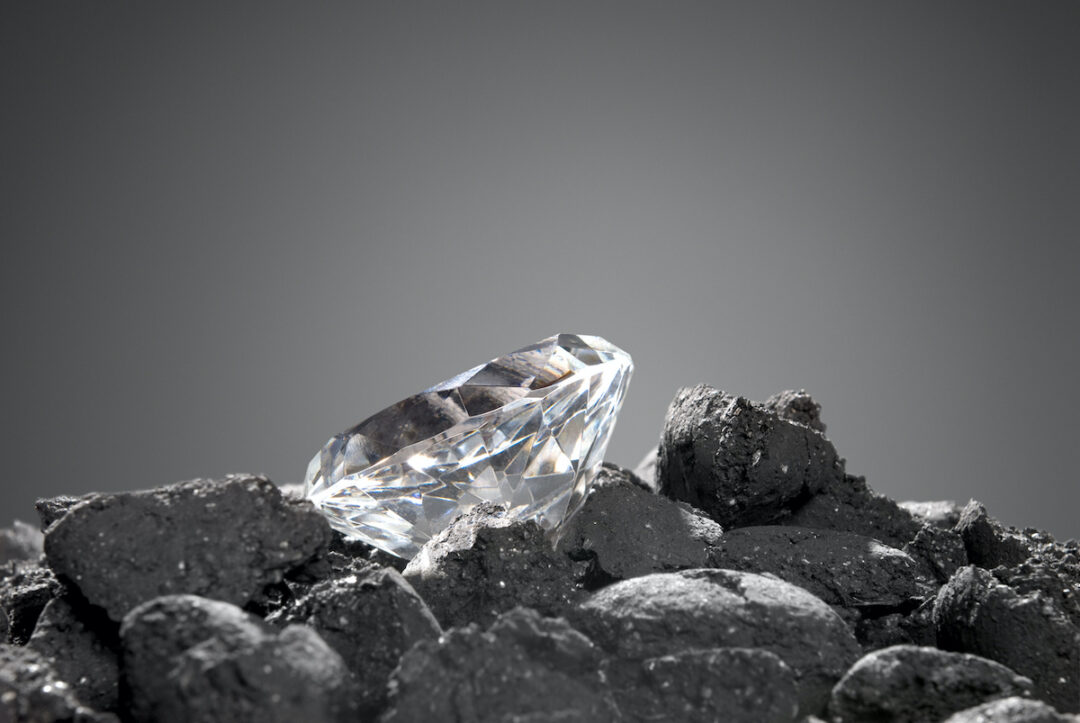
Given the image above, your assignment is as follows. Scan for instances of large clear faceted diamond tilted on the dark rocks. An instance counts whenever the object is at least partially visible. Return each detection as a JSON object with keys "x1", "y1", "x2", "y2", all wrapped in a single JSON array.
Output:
[{"x1": 305, "y1": 334, "x2": 634, "y2": 559}]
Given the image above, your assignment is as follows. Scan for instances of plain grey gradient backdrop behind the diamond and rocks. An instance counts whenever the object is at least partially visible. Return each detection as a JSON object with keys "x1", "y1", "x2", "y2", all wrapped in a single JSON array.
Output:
[{"x1": 0, "y1": 1, "x2": 1080, "y2": 537}]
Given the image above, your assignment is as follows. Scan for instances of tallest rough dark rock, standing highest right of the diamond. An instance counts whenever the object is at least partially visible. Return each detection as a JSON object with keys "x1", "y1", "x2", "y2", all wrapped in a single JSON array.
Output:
[{"x1": 657, "y1": 385, "x2": 843, "y2": 530}]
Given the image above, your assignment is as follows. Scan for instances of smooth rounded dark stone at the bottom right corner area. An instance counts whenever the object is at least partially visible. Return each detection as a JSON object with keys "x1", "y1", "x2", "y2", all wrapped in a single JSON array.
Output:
[{"x1": 828, "y1": 645, "x2": 1031, "y2": 723}]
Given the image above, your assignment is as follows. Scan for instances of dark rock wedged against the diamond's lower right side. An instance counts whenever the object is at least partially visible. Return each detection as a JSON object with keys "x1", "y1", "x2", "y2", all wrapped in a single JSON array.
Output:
[{"x1": 558, "y1": 467, "x2": 724, "y2": 579}]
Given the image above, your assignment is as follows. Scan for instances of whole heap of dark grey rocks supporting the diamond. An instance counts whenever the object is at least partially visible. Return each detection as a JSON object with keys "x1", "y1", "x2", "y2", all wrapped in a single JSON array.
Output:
[{"x1": 0, "y1": 386, "x2": 1080, "y2": 723}]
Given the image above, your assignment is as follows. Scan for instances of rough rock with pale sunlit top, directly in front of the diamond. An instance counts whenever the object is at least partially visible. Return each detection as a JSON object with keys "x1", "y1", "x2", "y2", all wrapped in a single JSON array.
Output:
[{"x1": 404, "y1": 503, "x2": 585, "y2": 628}]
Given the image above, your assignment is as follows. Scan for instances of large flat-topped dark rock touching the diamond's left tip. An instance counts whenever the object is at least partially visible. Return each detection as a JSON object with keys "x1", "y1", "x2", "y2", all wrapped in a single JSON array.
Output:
[{"x1": 45, "y1": 476, "x2": 330, "y2": 620}]
